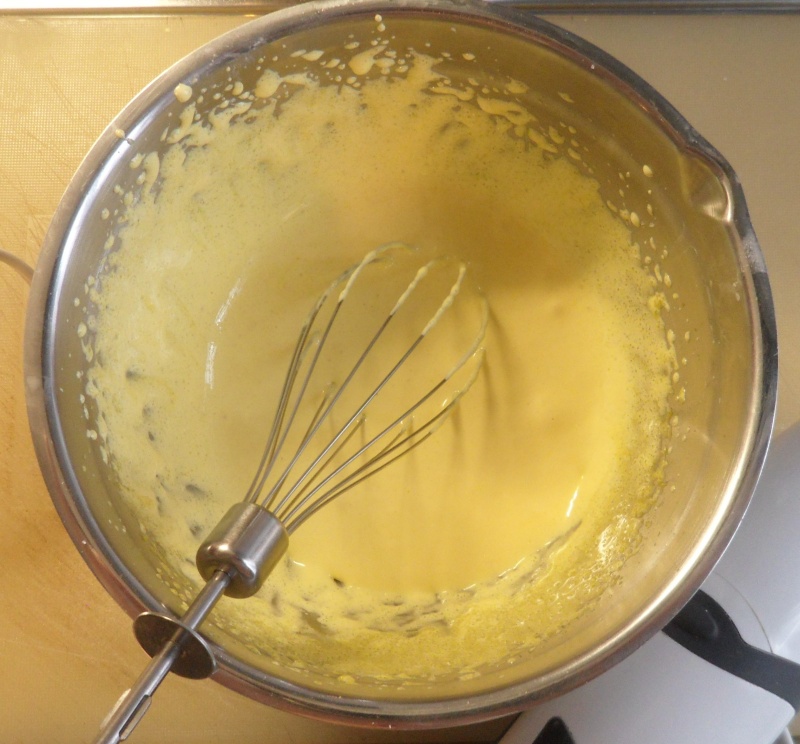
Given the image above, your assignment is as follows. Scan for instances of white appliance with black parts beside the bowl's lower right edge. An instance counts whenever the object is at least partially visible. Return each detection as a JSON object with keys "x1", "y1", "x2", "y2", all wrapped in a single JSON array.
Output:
[{"x1": 501, "y1": 424, "x2": 800, "y2": 744}]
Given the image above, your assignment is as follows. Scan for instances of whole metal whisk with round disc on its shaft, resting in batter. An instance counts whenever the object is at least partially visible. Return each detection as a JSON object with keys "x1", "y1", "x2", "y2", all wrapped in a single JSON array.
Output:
[{"x1": 95, "y1": 243, "x2": 488, "y2": 744}]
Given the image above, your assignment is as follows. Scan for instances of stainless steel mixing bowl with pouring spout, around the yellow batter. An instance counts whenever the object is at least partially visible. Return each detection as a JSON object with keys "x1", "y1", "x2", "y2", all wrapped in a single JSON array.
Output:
[{"x1": 25, "y1": 0, "x2": 777, "y2": 727}]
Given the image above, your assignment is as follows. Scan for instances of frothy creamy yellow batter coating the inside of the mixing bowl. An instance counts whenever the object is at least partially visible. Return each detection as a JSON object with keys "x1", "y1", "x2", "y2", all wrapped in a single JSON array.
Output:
[{"x1": 84, "y1": 32, "x2": 674, "y2": 678}]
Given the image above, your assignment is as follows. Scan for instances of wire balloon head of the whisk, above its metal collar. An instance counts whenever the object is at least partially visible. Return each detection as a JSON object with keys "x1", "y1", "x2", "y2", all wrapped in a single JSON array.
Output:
[{"x1": 245, "y1": 244, "x2": 488, "y2": 533}]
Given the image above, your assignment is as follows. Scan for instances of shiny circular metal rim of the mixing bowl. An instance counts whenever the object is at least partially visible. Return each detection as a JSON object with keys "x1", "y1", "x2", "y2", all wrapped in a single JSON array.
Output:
[{"x1": 24, "y1": 0, "x2": 777, "y2": 728}]
